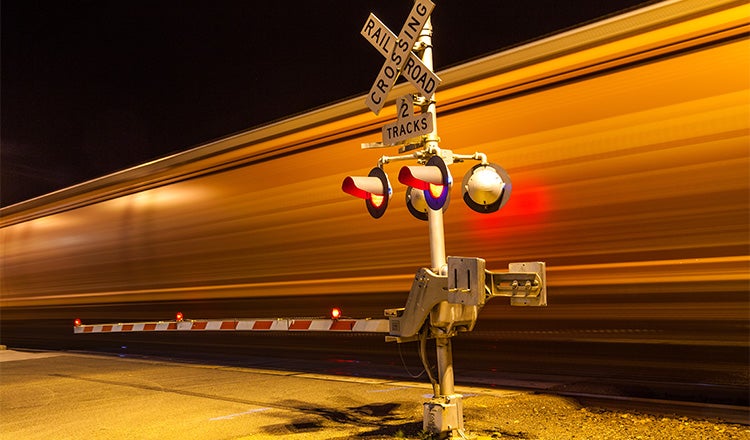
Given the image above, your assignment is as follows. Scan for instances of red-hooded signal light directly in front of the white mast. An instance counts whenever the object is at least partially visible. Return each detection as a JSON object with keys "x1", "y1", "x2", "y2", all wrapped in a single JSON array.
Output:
[{"x1": 398, "y1": 156, "x2": 453, "y2": 211}]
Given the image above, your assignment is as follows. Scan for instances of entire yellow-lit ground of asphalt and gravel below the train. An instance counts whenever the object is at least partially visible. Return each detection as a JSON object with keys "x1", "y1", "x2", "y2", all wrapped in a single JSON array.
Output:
[{"x1": 0, "y1": 350, "x2": 750, "y2": 440}]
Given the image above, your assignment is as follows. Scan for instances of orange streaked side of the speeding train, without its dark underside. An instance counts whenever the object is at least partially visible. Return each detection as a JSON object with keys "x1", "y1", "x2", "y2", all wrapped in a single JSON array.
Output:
[{"x1": 0, "y1": 2, "x2": 750, "y2": 307}]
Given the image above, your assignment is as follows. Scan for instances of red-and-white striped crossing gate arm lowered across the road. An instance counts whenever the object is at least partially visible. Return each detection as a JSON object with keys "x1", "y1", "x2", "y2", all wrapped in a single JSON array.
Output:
[{"x1": 73, "y1": 318, "x2": 389, "y2": 334}]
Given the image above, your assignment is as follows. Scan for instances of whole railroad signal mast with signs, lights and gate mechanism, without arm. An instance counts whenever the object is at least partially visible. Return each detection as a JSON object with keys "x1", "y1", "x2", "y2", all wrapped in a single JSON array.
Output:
[{"x1": 341, "y1": 0, "x2": 547, "y2": 438}]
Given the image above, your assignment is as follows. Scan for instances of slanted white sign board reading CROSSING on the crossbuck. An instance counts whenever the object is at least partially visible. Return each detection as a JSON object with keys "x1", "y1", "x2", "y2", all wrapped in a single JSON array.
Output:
[{"x1": 365, "y1": 0, "x2": 435, "y2": 115}]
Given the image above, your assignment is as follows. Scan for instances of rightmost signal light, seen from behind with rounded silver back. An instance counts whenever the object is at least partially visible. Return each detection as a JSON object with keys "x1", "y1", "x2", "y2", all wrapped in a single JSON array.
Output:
[{"x1": 461, "y1": 163, "x2": 512, "y2": 214}]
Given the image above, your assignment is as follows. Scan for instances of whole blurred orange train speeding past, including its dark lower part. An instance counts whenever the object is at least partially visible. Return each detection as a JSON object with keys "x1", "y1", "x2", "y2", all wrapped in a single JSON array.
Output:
[{"x1": 0, "y1": 0, "x2": 750, "y2": 406}]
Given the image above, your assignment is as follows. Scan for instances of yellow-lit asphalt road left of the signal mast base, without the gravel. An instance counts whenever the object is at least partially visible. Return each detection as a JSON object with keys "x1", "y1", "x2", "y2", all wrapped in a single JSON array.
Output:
[{"x1": 0, "y1": 350, "x2": 519, "y2": 439}]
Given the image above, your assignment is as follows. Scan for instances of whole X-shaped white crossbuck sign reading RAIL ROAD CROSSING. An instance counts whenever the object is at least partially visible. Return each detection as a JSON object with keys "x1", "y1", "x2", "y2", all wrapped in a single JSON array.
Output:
[{"x1": 360, "y1": 0, "x2": 440, "y2": 115}]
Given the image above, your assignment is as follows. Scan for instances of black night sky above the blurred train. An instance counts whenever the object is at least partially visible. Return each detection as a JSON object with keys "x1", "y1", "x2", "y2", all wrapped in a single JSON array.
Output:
[{"x1": 0, "y1": 0, "x2": 653, "y2": 206}]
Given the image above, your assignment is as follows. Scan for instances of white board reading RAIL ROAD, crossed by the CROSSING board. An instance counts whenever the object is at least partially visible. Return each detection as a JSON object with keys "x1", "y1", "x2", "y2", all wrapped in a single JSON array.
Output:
[{"x1": 360, "y1": 14, "x2": 442, "y2": 101}]
